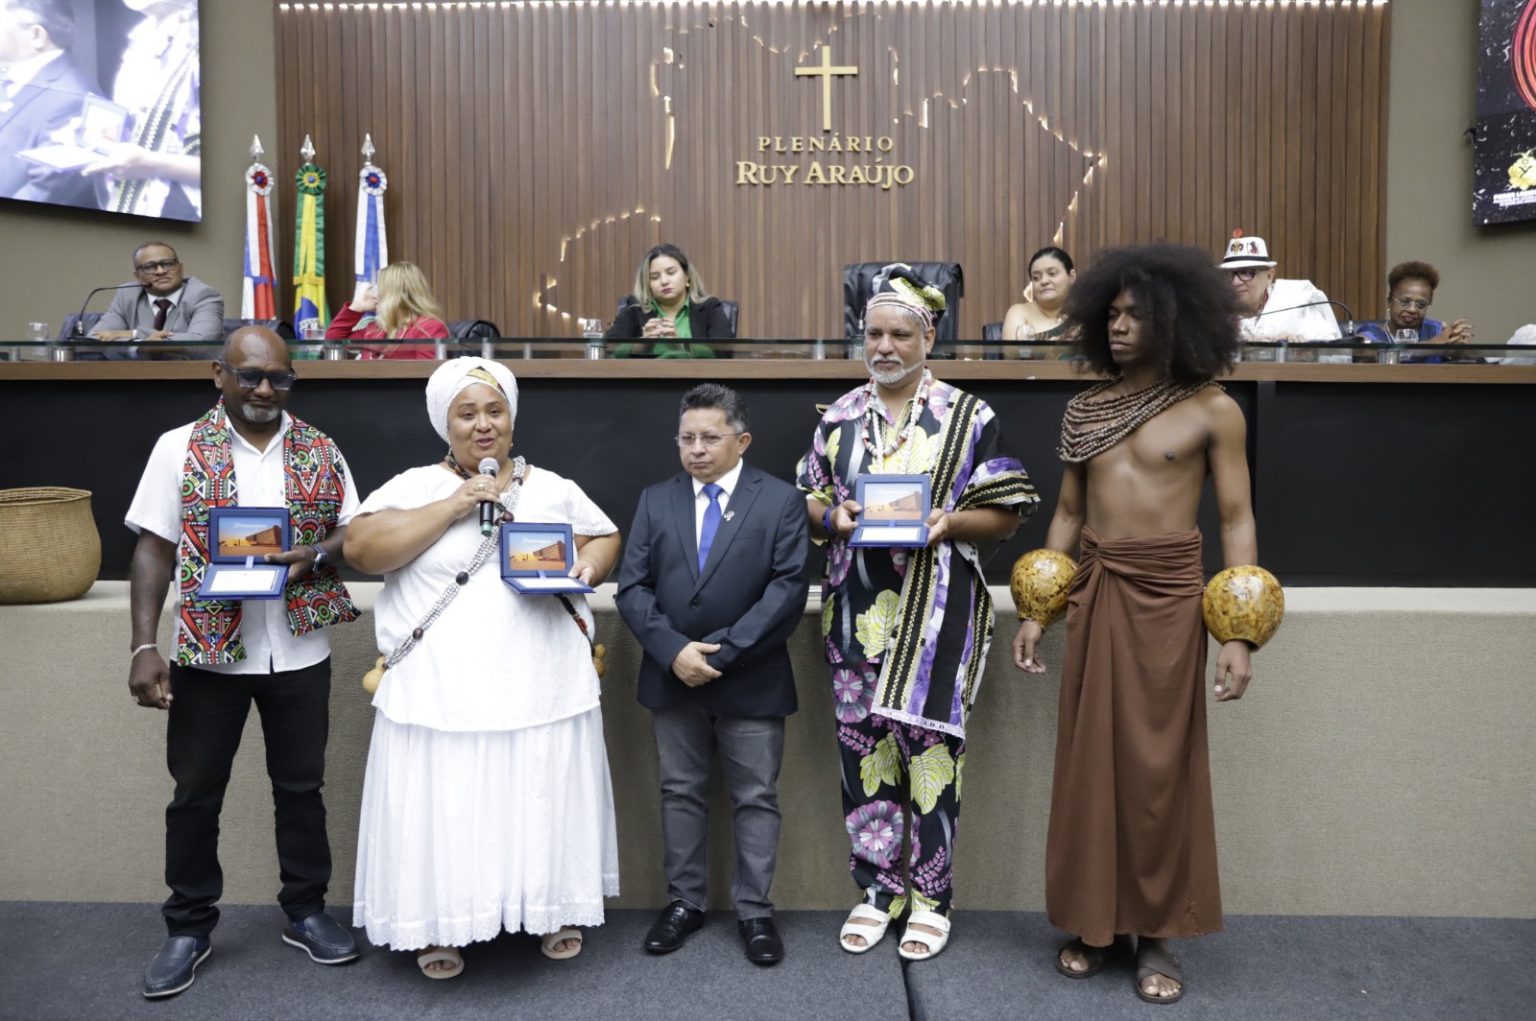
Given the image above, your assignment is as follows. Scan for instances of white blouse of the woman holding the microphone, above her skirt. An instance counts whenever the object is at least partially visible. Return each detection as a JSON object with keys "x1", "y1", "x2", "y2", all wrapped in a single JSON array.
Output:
[{"x1": 359, "y1": 465, "x2": 617, "y2": 731}]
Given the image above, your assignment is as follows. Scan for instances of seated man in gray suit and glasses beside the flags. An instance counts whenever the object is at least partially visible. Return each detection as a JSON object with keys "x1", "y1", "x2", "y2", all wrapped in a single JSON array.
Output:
[{"x1": 91, "y1": 241, "x2": 224, "y2": 359}]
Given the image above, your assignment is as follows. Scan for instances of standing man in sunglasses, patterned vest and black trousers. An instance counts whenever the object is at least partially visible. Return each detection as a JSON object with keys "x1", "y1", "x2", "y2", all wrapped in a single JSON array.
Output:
[{"x1": 126, "y1": 327, "x2": 358, "y2": 998}]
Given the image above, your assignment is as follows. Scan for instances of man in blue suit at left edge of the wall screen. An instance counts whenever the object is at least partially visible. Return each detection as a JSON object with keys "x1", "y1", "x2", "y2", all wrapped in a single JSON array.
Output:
[{"x1": 0, "y1": 0, "x2": 100, "y2": 209}]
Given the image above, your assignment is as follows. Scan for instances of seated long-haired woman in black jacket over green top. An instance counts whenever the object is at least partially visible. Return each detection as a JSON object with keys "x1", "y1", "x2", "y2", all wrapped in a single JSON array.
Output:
[{"x1": 604, "y1": 244, "x2": 736, "y2": 358}]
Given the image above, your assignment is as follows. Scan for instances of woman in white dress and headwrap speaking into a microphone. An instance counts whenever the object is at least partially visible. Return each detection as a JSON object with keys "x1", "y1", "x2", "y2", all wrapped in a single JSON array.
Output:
[{"x1": 346, "y1": 358, "x2": 619, "y2": 978}]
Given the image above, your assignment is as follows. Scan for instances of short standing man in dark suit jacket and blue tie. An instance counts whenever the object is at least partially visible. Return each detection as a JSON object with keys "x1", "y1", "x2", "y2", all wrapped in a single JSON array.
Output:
[{"x1": 617, "y1": 384, "x2": 808, "y2": 964}]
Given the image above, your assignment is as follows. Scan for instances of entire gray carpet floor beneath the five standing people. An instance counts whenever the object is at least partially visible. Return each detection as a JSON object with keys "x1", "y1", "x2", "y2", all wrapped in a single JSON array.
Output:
[{"x1": 0, "y1": 901, "x2": 1536, "y2": 1021}]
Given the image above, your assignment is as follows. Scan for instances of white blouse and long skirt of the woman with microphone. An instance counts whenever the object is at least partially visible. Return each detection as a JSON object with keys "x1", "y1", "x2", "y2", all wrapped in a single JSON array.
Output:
[{"x1": 352, "y1": 465, "x2": 619, "y2": 950}]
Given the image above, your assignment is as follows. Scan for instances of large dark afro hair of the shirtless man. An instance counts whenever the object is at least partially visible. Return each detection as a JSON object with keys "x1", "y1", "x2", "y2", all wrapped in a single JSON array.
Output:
[{"x1": 1066, "y1": 244, "x2": 1241, "y2": 384}]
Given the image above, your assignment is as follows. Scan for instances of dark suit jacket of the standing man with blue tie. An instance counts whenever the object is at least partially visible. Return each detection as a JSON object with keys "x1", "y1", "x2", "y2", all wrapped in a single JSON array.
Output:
[{"x1": 617, "y1": 465, "x2": 809, "y2": 719}]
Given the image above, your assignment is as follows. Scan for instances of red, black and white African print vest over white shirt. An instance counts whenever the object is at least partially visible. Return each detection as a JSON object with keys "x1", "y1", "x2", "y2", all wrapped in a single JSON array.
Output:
[{"x1": 177, "y1": 399, "x2": 358, "y2": 666}]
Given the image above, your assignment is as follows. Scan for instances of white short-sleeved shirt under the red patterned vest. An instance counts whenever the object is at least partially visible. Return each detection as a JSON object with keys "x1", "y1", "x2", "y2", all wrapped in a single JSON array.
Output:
[{"x1": 124, "y1": 411, "x2": 358, "y2": 674}]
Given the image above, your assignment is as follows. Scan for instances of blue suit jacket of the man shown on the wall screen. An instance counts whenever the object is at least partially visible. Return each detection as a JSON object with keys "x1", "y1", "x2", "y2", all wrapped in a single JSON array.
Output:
[{"x1": 0, "y1": 54, "x2": 100, "y2": 209}]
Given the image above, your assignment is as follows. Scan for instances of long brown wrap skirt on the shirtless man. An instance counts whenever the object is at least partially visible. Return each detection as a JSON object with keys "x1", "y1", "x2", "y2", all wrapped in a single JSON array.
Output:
[{"x1": 1046, "y1": 528, "x2": 1221, "y2": 946}]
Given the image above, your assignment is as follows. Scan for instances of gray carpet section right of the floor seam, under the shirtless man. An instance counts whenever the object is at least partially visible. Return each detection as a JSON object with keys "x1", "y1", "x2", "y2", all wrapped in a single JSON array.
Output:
[{"x1": 906, "y1": 912, "x2": 1536, "y2": 1021}]
